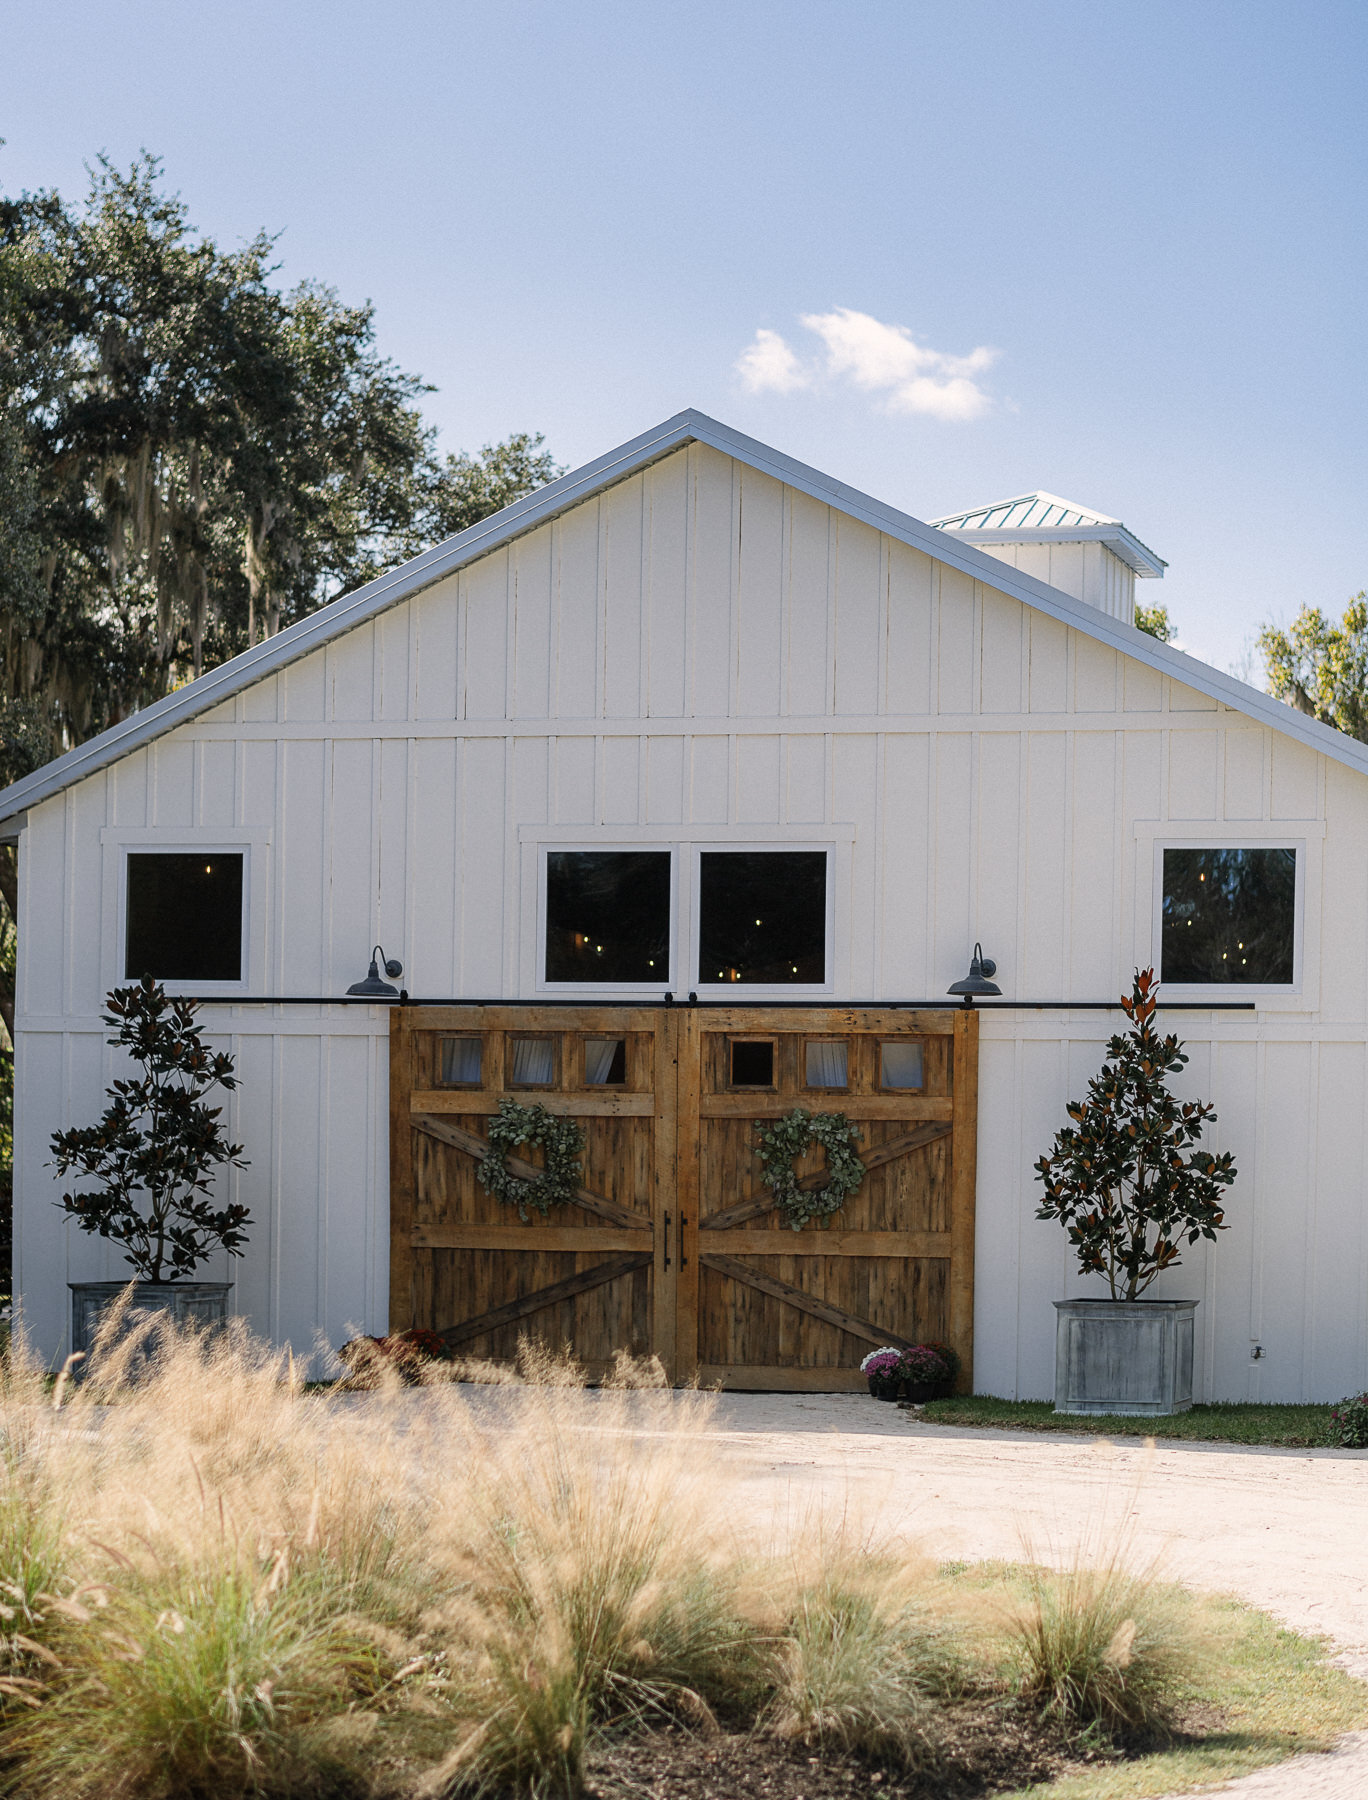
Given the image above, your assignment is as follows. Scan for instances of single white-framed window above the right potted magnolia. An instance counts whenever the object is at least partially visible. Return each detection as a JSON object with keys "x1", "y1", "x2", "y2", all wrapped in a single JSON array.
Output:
[{"x1": 1150, "y1": 828, "x2": 1319, "y2": 1004}]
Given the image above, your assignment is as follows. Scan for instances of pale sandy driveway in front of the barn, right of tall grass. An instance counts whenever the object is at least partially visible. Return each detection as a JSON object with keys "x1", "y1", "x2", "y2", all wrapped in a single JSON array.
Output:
[{"x1": 698, "y1": 1393, "x2": 1368, "y2": 1800}]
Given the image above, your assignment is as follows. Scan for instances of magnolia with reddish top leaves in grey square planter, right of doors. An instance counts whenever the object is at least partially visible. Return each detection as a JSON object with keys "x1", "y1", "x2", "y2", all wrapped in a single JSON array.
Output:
[{"x1": 1035, "y1": 968, "x2": 1235, "y2": 1413}]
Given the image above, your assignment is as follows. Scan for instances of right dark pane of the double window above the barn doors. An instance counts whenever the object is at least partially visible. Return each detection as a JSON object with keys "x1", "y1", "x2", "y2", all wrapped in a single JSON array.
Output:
[{"x1": 698, "y1": 850, "x2": 826, "y2": 986}]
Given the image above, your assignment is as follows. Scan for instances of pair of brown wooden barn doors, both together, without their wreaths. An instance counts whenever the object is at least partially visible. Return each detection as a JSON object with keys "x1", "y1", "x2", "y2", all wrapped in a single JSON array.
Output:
[{"x1": 391, "y1": 1004, "x2": 977, "y2": 1391}]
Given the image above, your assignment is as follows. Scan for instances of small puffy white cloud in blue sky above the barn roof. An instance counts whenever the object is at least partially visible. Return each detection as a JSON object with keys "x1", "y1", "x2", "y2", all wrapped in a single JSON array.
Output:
[{"x1": 736, "y1": 306, "x2": 997, "y2": 423}]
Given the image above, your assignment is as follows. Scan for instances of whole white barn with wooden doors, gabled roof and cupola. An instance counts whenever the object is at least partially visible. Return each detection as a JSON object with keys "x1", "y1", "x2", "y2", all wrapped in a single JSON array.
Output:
[{"x1": 0, "y1": 412, "x2": 1368, "y2": 1400}]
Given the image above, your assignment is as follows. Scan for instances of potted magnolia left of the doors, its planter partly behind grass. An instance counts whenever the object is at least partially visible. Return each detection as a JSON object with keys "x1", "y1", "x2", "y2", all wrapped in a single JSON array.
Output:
[{"x1": 52, "y1": 976, "x2": 250, "y2": 1352}]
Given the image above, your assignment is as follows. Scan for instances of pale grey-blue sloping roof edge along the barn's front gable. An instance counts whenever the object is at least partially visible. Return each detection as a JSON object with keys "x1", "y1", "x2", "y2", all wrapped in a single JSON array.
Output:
[{"x1": 0, "y1": 410, "x2": 1368, "y2": 837}]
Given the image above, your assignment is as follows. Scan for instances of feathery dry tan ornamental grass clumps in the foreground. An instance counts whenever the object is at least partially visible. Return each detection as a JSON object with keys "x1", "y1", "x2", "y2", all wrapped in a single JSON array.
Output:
[{"x1": 0, "y1": 1330, "x2": 1209, "y2": 1800}]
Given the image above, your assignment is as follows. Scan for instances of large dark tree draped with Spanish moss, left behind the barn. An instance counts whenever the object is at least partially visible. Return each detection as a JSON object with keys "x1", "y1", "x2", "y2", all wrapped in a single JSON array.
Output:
[{"x1": 0, "y1": 155, "x2": 560, "y2": 1288}]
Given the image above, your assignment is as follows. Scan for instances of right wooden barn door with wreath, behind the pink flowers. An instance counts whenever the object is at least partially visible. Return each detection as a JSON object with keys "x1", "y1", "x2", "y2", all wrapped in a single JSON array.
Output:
[{"x1": 677, "y1": 1006, "x2": 977, "y2": 1393}]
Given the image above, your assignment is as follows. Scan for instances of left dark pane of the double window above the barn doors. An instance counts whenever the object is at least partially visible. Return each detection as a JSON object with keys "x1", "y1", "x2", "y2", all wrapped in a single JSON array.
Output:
[{"x1": 545, "y1": 850, "x2": 671, "y2": 986}]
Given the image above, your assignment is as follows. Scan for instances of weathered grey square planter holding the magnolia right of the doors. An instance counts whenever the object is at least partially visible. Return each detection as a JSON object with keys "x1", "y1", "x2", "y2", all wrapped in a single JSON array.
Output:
[{"x1": 1055, "y1": 1300, "x2": 1197, "y2": 1417}]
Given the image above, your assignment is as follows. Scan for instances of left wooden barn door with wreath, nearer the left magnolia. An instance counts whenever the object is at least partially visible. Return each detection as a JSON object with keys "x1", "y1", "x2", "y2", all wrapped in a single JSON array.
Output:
[{"x1": 389, "y1": 1006, "x2": 675, "y2": 1372}]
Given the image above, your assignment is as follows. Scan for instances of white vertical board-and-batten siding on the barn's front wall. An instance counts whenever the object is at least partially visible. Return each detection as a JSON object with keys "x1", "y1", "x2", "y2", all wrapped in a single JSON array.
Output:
[{"x1": 16, "y1": 445, "x2": 1368, "y2": 1399}]
